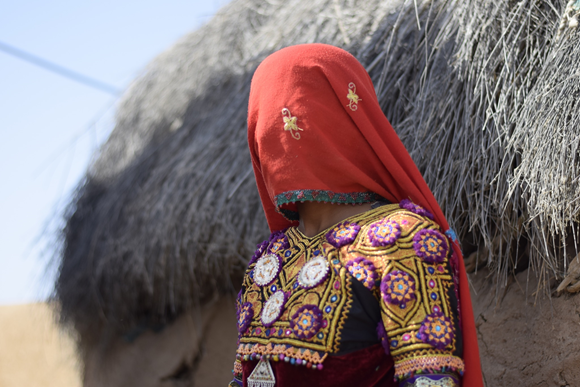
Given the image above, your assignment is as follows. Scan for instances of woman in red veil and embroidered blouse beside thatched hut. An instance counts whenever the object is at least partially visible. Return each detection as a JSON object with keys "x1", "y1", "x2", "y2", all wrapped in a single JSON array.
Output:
[{"x1": 231, "y1": 44, "x2": 483, "y2": 387}]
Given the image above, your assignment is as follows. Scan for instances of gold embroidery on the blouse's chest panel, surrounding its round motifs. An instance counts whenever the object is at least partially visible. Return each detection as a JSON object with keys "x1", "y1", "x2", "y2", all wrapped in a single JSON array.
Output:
[{"x1": 238, "y1": 228, "x2": 352, "y2": 364}]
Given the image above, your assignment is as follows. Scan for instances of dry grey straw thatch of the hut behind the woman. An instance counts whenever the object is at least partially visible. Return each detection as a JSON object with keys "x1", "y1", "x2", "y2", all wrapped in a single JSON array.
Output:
[{"x1": 55, "y1": 0, "x2": 580, "y2": 344}]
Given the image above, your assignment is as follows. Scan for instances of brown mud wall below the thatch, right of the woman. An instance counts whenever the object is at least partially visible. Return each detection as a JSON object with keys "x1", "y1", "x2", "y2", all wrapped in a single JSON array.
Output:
[{"x1": 470, "y1": 269, "x2": 580, "y2": 387}]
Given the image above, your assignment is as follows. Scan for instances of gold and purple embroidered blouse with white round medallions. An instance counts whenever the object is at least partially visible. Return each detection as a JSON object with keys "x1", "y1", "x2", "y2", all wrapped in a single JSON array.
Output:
[{"x1": 230, "y1": 201, "x2": 463, "y2": 387}]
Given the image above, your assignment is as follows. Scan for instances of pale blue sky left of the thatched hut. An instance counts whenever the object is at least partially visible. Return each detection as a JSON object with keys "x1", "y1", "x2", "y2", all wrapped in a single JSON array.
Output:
[{"x1": 0, "y1": 0, "x2": 226, "y2": 304}]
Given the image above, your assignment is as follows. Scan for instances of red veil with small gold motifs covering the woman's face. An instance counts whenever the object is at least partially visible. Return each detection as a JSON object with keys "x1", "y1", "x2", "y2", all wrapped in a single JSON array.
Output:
[{"x1": 248, "y1": 44, "x2": 483, "y2": 387}]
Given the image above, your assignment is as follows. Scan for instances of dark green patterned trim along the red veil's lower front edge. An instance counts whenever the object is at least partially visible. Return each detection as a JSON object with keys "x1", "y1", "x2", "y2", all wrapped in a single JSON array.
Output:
[{"x1": 274, "y1": 189, "x2": 383, "y2": 221}]
